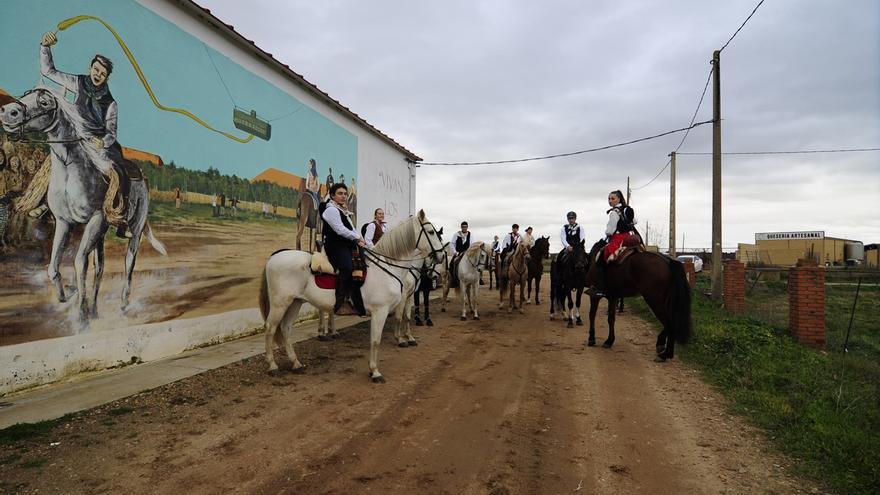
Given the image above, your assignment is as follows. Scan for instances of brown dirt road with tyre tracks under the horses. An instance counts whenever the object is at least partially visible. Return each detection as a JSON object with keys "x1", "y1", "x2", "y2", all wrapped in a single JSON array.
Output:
[{"x1": 0, "y1": 284, "x2": 816, "y2": 495}]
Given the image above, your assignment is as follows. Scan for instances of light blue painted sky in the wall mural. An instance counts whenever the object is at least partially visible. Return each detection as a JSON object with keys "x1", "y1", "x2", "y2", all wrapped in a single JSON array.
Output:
[{"x1": 0, "y1": 0, "x2": 357, "y2": 182}]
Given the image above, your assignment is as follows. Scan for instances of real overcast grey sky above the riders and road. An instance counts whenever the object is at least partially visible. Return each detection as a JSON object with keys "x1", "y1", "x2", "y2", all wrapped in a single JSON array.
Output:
[{"x1": 198, "y1": 0, "x2": 880, "y2": 250}]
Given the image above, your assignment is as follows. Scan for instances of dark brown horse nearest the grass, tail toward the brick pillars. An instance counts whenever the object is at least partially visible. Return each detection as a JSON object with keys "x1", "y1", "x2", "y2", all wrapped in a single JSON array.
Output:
[{"x1": 587, "y1": 242, "x2": 691, "y2": 361}]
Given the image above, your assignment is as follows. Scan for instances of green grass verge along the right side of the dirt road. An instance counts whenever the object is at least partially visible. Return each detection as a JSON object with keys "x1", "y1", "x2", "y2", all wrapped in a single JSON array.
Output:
[{"x1": 631, "y1": 276, "x2": 880, "y2": 494}]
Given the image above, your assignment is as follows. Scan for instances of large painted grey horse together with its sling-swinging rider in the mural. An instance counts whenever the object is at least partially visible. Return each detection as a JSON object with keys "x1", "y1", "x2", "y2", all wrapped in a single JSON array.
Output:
[{"x1": 0, "y1": 33, "x2": 165, "y2": 326}]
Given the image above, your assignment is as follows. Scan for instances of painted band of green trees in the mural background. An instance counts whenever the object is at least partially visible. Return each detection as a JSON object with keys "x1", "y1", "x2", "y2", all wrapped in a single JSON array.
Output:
[{"x1": 135, "y1": 160, "x2": 299, "y2": 208}]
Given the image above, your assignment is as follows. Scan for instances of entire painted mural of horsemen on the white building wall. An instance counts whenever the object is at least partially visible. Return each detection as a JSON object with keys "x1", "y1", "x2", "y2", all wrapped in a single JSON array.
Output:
[{"x1": 0, "y1": 0, "x2": 358, "y2": 345}]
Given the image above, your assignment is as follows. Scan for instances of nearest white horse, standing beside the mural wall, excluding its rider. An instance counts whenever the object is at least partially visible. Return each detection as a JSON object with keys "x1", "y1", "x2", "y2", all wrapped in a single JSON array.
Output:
[{"x1": 260, "y1": 210, "x2": 443, "y2": 383}]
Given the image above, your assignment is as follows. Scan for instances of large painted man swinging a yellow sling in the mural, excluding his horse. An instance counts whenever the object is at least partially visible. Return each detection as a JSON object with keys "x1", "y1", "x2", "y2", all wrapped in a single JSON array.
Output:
[{"x1": 40, "y1": 31, "x2": 130, "y2": 237}]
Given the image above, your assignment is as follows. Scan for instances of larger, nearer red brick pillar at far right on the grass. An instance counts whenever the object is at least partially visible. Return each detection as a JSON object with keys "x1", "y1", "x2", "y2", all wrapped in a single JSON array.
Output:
[{"x1": 788, "y1": 266, "x2": 825, "y2": 347}]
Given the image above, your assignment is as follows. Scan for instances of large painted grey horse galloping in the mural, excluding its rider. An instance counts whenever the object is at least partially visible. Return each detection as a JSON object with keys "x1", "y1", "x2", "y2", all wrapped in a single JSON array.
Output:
[{"x1": 0, "y1": 87, "x2": 166, "y2": 327}]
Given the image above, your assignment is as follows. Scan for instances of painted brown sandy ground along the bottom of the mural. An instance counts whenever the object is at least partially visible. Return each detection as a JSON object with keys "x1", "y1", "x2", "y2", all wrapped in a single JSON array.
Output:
[{"x1": 0, "y1": 215, "x2": 296, "y2": 345}]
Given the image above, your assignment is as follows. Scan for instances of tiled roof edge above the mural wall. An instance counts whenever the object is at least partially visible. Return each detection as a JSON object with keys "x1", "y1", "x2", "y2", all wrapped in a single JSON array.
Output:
[{"x1": 175, "y1": 0, "x2": 422, "y2": 162}]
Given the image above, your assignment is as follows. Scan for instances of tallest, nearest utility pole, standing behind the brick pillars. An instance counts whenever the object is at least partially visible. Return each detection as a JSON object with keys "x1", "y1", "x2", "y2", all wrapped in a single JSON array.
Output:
[{"x1": 712, "y1": 50, "x2": 723, "y2": 300}]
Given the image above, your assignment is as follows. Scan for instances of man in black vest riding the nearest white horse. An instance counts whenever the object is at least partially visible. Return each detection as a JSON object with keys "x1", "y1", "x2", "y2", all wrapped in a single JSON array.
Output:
[{"x1": 321, "y1": 184, "x2": 367, "y2": 316}]
